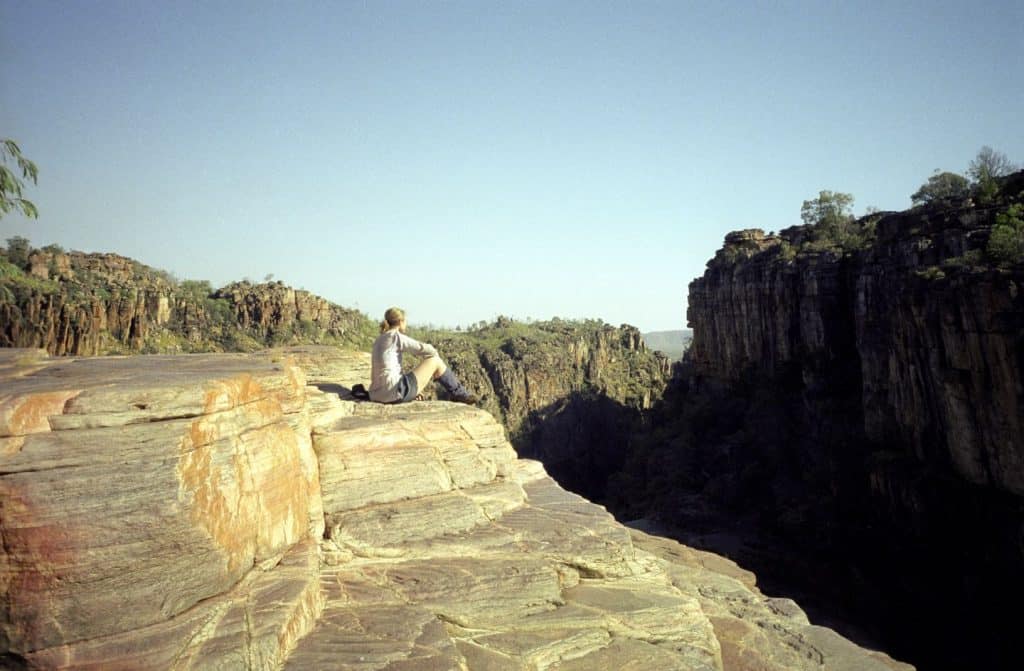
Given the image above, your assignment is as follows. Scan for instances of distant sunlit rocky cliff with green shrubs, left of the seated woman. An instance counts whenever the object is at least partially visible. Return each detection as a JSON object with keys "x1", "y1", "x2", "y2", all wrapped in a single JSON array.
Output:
[{"x1": 0, "y1": 249, "x2": 373, "y2": 355}]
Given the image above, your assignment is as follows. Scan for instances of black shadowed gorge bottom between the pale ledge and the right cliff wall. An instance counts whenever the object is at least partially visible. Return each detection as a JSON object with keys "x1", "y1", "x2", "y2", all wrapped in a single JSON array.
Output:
[{"x1": 518, "y1": 376, "x2": 1024, "y2": 671}]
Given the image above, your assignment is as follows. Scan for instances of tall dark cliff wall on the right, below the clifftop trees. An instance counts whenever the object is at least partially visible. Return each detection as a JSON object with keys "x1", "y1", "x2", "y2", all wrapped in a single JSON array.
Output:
[{"x1": 675, "y1": 173, "x2": 1024, "y2": 668}]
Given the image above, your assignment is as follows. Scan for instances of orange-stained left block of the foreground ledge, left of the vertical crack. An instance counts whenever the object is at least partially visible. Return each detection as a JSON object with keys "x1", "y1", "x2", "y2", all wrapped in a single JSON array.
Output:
[{"x1": 0, "y1": 350, "x2": 323, "y2": 668}]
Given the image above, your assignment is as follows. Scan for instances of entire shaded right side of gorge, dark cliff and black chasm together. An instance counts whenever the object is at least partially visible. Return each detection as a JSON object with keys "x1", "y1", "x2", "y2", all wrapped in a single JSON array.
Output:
[{"x1": 491, "y1": 171, "x2": 1024, "y2": 670}]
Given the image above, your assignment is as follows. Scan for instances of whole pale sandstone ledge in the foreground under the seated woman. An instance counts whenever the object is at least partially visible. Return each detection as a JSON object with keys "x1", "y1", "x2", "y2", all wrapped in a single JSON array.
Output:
[{"x1": 0, "y1": 347, "x2": 910, "y2": 671}]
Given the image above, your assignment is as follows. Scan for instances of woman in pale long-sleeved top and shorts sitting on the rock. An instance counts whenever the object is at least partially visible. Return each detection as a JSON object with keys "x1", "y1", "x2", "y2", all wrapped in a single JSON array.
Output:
[{"x1": 370, "y1": 307, "x2": 476, "y2": 405}]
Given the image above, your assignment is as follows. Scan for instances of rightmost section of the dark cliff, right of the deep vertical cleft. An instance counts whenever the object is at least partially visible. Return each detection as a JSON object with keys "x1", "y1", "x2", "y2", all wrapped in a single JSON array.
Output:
[{"x1": 854, "y1": 210, "x2": 1024, "y2": 496}]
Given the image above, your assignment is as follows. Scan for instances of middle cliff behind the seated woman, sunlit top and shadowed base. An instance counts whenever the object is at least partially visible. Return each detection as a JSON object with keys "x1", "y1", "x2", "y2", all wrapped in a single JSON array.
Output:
[{"x1": 415, "y1": 319, "x2": 670, "y2": 499}]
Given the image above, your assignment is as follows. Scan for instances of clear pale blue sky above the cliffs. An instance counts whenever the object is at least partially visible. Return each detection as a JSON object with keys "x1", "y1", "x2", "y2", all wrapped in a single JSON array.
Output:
[{"x1": 0, "y1": 0, "x2": 1024, "y2": 331}]
